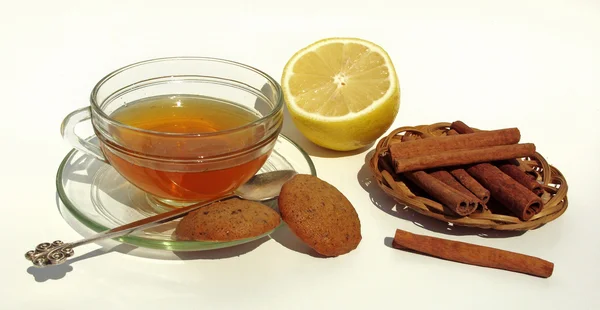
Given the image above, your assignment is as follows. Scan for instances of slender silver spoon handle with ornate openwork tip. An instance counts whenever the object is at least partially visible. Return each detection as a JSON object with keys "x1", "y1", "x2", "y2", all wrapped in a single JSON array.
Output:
[{"x1": 25, "y1": 194, "x2": 237, "y2": 267}]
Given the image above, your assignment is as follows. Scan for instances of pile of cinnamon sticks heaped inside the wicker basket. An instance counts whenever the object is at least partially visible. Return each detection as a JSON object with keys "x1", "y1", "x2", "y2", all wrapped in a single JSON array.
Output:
[{"x1": 389, "y1": 121, "x2": 544, "y2": 221}]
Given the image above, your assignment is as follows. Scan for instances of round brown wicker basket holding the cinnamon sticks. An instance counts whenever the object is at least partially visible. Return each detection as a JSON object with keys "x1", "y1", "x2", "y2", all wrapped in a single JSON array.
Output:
[{"x1": 370, "y1": 123, "x2": 568, "y2": 230}]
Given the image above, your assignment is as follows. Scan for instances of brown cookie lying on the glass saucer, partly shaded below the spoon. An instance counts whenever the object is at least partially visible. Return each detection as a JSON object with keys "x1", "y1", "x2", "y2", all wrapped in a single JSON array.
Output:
[{"x1": 175, "y1": 198, "x2": 281, "y2": 241}]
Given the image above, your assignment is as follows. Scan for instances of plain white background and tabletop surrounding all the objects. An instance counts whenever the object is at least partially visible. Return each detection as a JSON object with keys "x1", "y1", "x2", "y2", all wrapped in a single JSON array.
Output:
[{"x1": 0, "y1": 0, "x2": 600, "y2": 309}]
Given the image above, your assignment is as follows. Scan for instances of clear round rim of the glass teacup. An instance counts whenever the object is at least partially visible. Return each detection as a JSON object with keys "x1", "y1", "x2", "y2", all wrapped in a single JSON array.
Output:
[{"x1": 90, "y1": 56, "x2": 284, "y2": 137}]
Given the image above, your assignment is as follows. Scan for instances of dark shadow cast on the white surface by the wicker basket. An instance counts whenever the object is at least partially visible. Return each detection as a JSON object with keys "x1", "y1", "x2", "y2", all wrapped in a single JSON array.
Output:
[{"x1": 356, "y1": 150, "x2": 525, "y2": 237}]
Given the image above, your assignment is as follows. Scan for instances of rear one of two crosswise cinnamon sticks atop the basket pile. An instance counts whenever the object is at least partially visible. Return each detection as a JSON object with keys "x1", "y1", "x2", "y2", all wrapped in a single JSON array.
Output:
[{"x1": 390, "y1": 128, "x2": 521, "y2": 158}]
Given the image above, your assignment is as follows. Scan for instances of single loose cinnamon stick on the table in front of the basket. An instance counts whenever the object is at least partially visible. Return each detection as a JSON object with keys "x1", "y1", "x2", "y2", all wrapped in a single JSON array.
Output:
[{"x1": 392, "y1": 229, "x2": 554, "y2": 278}]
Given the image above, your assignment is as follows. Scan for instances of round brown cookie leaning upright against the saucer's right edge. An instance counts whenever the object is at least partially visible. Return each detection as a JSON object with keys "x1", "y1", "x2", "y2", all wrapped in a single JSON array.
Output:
[{"x1": 279, "y1": 175, "x2": 362, "y2": 256}]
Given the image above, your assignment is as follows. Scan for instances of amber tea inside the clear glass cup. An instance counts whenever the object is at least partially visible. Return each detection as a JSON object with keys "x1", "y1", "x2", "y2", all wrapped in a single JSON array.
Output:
[{"x1": 103, "y1": 96, "x2": 269, "y2": 202}]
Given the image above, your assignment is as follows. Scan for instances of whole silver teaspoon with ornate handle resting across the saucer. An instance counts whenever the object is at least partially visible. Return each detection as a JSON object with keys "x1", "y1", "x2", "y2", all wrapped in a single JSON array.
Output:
[{"x1": 25, "y1": 170, "x2": 296, "y2": 267}]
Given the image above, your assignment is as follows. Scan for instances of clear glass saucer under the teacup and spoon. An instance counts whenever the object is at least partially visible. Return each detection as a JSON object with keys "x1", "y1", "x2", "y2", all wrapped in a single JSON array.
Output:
[{"x1": 56, "y1": 135, "x2": 316, "y2": 251}]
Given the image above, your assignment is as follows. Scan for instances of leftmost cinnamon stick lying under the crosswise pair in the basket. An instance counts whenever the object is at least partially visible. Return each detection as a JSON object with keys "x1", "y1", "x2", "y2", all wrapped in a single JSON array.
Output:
[{"x1": 404, "y1": 171, "x2": 478, "y2": 216}]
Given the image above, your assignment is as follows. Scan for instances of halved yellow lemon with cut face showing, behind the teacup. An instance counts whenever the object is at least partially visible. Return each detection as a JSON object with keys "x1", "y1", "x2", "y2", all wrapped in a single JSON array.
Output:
[{"x1": 281, "y1": 38, "x2": 400, "y2": 151}]
